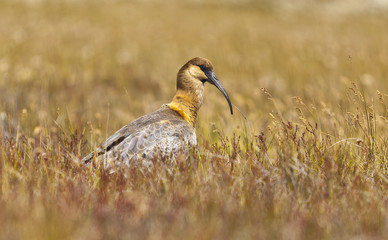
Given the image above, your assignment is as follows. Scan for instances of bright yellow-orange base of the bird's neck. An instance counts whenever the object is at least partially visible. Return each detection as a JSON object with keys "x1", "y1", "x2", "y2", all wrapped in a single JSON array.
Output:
[{"x1": 168, "y1": 90, "x2": 200, "y2": 127}]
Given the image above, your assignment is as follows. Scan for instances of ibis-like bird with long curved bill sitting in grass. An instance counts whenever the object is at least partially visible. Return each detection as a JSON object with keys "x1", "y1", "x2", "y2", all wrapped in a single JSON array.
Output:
[{"x1": 81, "y1": 57, "x2": 233, "y2": 167}]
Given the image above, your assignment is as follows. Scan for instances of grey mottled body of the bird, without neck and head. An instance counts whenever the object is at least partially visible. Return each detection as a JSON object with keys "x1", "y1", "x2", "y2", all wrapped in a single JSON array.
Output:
[{"x1": 82, "y1": 105, "x2": 197, "y2": 166}]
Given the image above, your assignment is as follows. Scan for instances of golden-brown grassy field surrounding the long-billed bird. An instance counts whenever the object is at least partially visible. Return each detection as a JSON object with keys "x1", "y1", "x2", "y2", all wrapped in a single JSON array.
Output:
[{"x1": 0, "y1": 1, "x2": 388, "y2": 240}]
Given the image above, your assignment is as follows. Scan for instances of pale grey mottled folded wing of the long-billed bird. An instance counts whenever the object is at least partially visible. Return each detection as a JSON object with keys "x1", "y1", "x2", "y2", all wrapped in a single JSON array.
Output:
[{"x1": 104, "y1": 120, "x2": 197, "y2": 165}]
